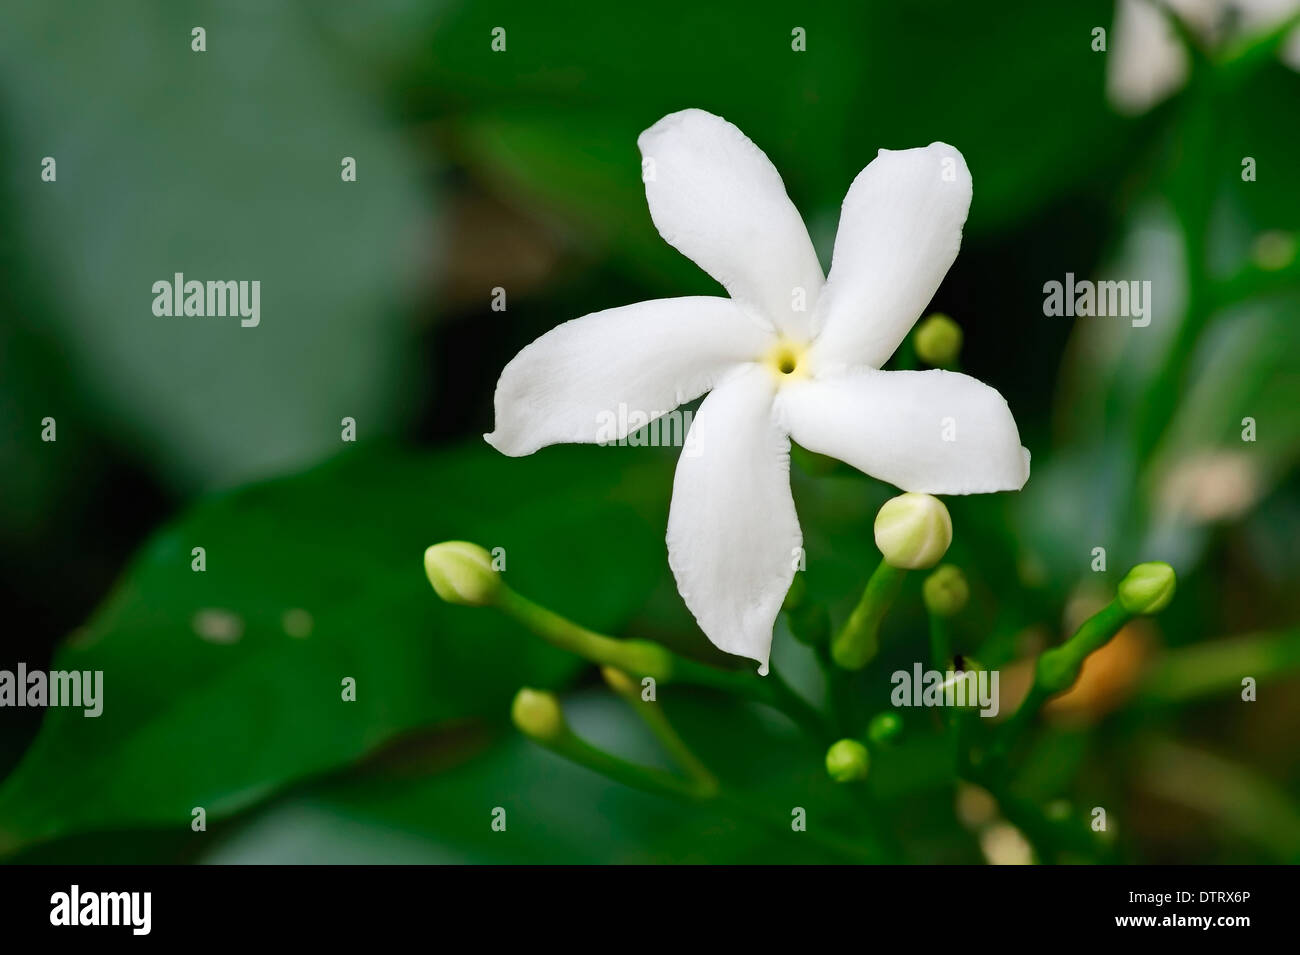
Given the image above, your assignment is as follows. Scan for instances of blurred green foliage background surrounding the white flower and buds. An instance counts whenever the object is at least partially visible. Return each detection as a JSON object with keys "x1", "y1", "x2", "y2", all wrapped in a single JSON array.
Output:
[{"x1": 0, "y1": 0, "x2": 1300, "y2": 861}]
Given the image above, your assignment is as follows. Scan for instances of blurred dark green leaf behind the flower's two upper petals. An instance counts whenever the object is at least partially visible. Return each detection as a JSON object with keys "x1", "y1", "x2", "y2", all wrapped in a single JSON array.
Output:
[{"x1": 404, "y1": 0, "x2": 1126, "y2": 272}]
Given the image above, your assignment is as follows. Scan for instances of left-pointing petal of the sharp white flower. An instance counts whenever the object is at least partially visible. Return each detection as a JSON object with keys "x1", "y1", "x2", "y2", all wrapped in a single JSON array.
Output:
[{"x1": 484, "y1": 296, "x2": 774, "y2": 457}]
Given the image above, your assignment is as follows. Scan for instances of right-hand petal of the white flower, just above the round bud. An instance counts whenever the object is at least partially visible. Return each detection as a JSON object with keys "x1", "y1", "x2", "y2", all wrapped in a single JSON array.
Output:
[{"x1": 776, "y1": 370, "x2": 1030, "y2": 494}]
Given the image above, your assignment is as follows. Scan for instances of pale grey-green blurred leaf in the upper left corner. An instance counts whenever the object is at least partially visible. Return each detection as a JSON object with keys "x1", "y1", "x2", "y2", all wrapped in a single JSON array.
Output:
[{"x1": 0, "y1": 1, "x2": 432, "y2": 489}]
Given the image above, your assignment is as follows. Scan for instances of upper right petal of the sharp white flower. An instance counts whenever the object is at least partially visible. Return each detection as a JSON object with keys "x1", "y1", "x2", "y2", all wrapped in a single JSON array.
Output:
[{"x1": 813, "y1": 143, "x2": 971, "y2": 372}]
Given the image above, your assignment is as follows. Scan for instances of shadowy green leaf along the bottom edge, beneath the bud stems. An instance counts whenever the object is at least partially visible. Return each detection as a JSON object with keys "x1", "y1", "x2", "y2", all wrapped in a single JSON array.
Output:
[{"x1": 205, "y1": 687, "x2": 972, "y2": 864}]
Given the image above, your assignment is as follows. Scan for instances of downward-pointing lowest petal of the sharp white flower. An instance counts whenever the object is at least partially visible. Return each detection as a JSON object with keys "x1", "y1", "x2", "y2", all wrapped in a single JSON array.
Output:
[{"x1": 668, "y1": 365, "x2": 803, "y2": 673}]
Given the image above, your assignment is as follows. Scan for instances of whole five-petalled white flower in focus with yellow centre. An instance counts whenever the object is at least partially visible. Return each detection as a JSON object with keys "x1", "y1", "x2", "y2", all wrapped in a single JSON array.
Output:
[{"x1": 485, "y1": 109, "x2": 1030, "y2": 673}]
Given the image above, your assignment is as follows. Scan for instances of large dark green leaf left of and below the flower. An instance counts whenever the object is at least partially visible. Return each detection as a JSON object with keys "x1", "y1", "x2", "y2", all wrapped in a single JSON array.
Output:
[{"x1": 0, "y1": 446, "x2": 670, "y2": 850}]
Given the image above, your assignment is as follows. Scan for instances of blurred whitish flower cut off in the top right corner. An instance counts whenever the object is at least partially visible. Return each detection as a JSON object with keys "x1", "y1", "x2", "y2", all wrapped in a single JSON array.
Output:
[{"x1": 1106, "y1": 0, "x2": 1300, "y2": 113}]
